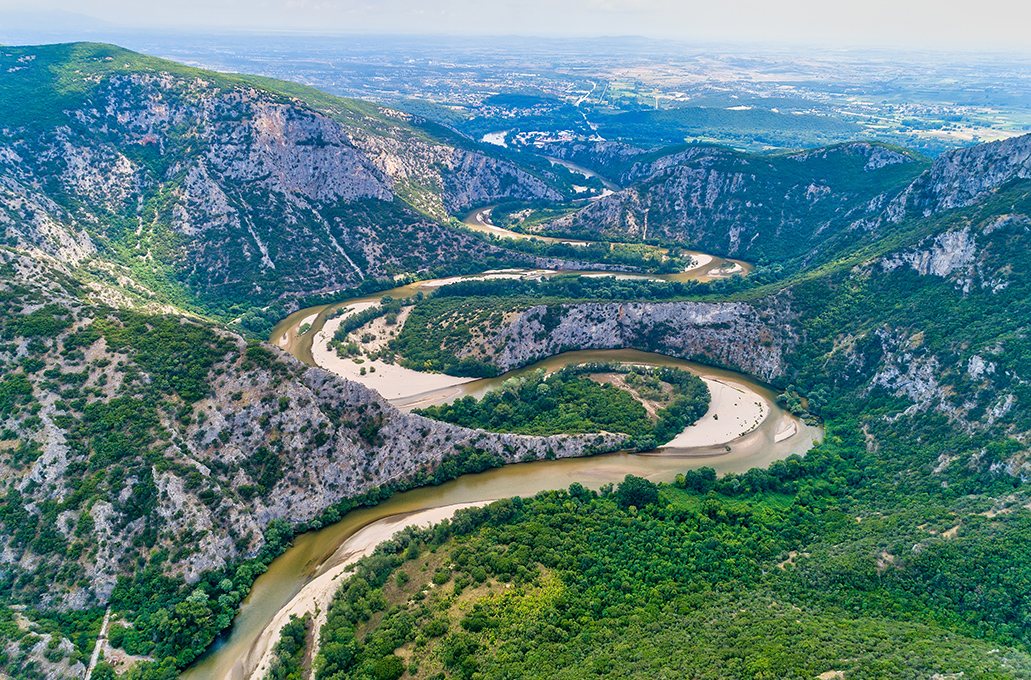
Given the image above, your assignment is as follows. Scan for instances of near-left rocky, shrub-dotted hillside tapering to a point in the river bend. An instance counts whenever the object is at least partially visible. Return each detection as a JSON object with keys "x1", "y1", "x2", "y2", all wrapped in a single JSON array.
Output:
[{"x1": 0, "y1": 248, "x2": 625, "y2": 666}]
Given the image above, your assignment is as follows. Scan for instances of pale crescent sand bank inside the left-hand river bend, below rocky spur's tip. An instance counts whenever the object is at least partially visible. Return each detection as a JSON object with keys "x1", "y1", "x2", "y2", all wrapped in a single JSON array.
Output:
[{"x1": 311, "y1": 302, "x2": 473, "y2": 400}]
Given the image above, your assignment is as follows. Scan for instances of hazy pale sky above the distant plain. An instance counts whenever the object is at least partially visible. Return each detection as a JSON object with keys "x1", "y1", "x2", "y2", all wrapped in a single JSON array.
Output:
[{"x1": 6, "y1": 0, "x2": 1031, "y2": 53}]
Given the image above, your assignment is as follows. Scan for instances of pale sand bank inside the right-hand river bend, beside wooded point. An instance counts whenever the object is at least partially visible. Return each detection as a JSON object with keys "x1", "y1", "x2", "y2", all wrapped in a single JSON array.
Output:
[{"x1": 659, "y1": 377, "x2": 771, "y2": 450}]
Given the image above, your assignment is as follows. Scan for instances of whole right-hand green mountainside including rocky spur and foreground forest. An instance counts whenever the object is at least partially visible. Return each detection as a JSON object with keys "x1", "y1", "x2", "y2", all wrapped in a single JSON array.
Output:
[{"x1": 317, "y1": 134, "x2": 1031, "y2": 680}]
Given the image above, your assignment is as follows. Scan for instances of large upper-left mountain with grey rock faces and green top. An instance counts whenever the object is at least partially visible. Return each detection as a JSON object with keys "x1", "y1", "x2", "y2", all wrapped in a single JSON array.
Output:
[{"x1": 0, "y1": 44, "x2": 573, "y2": 310}]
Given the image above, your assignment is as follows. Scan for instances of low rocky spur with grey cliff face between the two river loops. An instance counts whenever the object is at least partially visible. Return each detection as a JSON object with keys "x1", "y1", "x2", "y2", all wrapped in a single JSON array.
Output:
[{"x1": 395, "y1": 294, "x2": 799, "y2": 380}]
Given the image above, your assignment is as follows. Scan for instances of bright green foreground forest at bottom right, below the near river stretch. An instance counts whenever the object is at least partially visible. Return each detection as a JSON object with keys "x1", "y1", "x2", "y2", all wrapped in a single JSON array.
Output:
[{"x1": 317, "y1": 459, "x2": 1031, "y2": 680}]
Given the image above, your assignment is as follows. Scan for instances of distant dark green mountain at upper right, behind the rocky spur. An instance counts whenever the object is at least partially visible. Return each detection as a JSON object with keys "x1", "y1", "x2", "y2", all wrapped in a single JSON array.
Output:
[{"x1": 546, "y1": 135, "x2": 1031, "y2": 274}]
